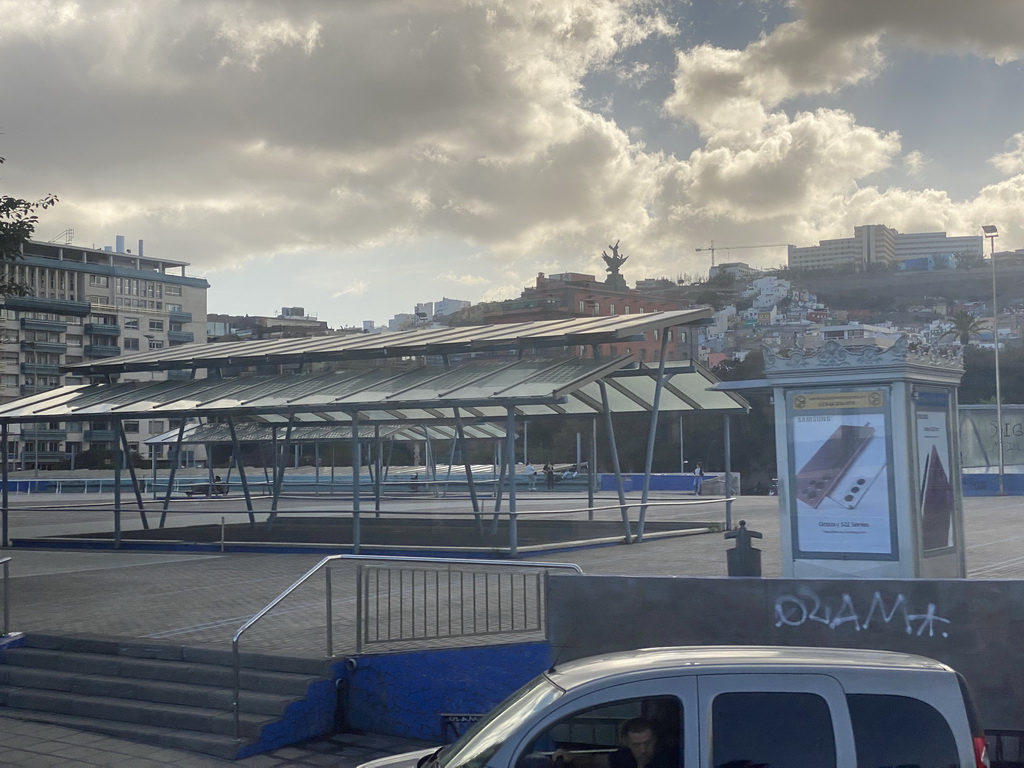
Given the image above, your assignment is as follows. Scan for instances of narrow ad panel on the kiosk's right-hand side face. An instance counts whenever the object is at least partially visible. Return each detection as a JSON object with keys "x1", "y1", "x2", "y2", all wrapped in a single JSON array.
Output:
[{"x1": 914, "y1": 389, "x2": 956, "y2": 552}]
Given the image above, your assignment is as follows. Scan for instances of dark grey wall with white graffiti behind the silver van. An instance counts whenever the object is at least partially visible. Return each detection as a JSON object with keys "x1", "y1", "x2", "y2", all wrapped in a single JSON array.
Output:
[{"x1": 548, "y1": 574, "x2": 1024, "y2": 730}]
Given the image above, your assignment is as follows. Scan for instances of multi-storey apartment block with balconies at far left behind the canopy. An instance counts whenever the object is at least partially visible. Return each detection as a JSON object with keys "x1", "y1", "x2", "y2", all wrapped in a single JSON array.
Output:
[{"x1": 0, "y1": 236, "x2": 210, "y2": 469}]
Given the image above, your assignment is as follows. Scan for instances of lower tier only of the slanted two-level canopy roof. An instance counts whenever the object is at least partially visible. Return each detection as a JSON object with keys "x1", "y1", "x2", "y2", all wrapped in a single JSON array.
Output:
[{"x1": 0, "y1": 355, "x2": 745, "y2": 426}]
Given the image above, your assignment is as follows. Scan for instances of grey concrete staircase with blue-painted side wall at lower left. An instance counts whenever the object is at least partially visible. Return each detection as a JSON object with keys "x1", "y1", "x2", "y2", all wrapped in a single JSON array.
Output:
[{"x1": 0, "y1": 635, "x2": 337, "y2": 759}]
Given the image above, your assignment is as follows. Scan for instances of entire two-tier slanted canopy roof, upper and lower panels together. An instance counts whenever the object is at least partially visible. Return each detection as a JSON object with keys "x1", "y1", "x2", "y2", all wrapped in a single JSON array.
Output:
[{"x1": 0, "y1": 308, "x2": 748, "y2": 426}]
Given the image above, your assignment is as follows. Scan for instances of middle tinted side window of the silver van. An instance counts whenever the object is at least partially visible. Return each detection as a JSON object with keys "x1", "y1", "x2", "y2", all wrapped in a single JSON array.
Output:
[{"x1": 711, "y1": 691, "x2": 831, "y2": 768}]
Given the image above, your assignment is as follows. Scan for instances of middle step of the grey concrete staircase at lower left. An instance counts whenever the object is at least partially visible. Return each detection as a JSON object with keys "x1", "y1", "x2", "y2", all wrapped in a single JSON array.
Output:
[{"x1": 0, "y1": 665, "x2": 295, "y2": 717}]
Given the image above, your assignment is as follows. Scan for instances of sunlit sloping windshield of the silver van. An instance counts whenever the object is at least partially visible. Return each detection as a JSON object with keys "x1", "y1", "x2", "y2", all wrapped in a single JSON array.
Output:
[{"x1": 436, "y1": 676, "x2": 564, "y2": 768}]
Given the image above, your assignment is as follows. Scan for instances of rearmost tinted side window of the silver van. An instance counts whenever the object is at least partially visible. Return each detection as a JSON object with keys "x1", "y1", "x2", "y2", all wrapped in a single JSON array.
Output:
[{"x1": 846, "y1": 693, "x2": 959, "y2": 768}]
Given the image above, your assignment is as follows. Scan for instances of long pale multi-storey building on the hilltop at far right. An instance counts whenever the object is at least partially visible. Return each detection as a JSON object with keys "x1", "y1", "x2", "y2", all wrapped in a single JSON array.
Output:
[{"x1": 788, "y1": 224, "x2": 984, "y2": 269}]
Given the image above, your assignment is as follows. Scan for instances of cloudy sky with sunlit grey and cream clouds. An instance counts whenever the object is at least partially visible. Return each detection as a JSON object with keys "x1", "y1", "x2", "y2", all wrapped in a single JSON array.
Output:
[{"x1": 0, "y1": 0, "x2": 1024, "y2": 326}]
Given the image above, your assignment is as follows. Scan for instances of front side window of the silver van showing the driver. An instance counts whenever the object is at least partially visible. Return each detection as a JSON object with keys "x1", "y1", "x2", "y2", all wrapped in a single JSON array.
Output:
[{"x1": 516, "y1": 696, "x2": 683, "y2": 768}]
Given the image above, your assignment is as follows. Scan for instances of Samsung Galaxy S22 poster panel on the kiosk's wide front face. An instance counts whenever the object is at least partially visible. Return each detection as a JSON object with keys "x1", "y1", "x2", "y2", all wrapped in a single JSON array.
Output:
[{"x1": 786, "y1": 389, "x2": 897, "y2": 559}]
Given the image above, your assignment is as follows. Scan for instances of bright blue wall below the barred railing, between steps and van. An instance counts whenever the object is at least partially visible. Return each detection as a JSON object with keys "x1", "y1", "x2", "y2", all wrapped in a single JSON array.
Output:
[{"x1": 338, "y1": 642, "x2": 552, "y2": 742}]
